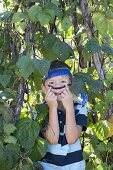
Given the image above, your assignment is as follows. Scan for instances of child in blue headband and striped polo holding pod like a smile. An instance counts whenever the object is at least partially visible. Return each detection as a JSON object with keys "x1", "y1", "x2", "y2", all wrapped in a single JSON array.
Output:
[{"x1": 40, "y1": 60, "x2": 87, "y2": 170}]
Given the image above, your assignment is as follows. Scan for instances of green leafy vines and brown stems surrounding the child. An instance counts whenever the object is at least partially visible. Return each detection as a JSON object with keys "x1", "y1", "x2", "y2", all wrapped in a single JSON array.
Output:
[{"x1": 0, "y1": 0, "x2": 113, "y2": 170}]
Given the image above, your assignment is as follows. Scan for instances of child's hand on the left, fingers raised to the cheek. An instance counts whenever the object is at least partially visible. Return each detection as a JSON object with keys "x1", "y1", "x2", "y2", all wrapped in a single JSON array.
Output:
[{"x1": 45, "y1": 87, "x2": 58, "y2": 109}]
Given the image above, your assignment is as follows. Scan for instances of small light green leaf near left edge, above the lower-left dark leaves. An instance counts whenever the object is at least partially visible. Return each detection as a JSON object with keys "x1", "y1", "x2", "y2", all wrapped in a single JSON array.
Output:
[{"x1": 4, "y1": 123, "x2": 16, "y2": 135}]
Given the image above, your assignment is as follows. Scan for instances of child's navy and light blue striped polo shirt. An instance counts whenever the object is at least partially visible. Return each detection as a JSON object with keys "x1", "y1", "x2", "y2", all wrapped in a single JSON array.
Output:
[{"x1": 40, "y1": 103, "x2": 87, "y2": 170}]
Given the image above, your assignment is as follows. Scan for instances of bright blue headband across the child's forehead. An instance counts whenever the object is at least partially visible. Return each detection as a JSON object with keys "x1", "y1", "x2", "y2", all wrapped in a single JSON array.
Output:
[{"x1": 44, "y1": 68, "x2": 71, "y2": 81}]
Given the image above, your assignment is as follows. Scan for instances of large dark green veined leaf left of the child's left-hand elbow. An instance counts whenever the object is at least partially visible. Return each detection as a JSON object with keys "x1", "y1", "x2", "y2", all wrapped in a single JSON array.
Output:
[{"x1": 16, "y1": 118, "x2": 40, "y2": 150}]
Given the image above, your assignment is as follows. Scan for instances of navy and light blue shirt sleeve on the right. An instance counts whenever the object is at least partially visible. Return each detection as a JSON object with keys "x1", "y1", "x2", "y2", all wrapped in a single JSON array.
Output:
[{"x1": 74, "y1": 104, "x2": 87, "y2": 131}]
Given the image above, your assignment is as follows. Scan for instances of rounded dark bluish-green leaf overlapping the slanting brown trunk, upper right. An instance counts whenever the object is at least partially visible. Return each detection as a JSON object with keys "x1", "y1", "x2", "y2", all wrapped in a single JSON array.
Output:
[{"x1": 85, "y1": 38, "x2": 101, "y2": 54}]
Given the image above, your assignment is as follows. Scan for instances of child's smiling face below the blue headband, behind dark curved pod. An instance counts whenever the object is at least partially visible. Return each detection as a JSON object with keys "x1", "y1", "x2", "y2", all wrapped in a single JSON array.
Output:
[{"x1": 44, "y1": 76, "x2": 70, "y2": 101}]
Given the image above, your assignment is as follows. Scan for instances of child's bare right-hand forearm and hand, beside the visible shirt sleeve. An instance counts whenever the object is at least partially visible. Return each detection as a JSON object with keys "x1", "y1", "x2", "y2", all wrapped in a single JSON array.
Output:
[{"x1": 62, "y1": 87, "x2": 82, "y2": 144}]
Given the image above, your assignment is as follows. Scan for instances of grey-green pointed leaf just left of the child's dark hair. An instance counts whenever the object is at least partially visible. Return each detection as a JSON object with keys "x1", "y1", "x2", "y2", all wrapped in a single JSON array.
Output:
[{"x1": 33, "y1": 59, "x2": 50, "y2": 76}]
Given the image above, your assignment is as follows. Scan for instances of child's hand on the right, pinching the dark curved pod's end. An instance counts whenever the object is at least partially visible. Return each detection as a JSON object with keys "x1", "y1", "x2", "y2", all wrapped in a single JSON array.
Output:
[{"x1": 61, "y1": 86, "x2": 73, "y2": 109}]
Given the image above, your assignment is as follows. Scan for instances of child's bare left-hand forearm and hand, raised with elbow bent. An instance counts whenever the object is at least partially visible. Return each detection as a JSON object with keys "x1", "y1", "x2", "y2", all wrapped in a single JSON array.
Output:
[{"x1": 43, "y1": 89, "x2": 59, "y2": 144}]
